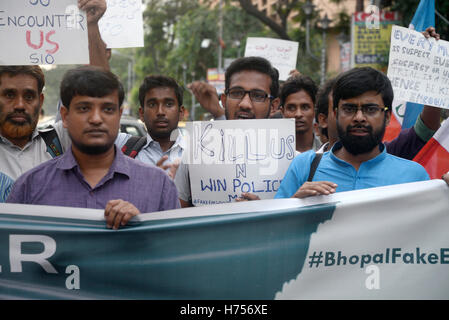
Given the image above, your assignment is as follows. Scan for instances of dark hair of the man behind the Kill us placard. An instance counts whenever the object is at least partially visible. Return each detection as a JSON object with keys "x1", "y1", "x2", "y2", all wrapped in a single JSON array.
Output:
[{"x1": 225, "y1": 57, "x2": 279, "y2": 98}]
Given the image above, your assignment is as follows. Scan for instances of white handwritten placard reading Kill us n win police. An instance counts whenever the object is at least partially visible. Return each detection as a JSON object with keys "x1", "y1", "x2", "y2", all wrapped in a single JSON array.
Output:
[{"x1": 183, "y1": 119, "x2": 296, "y2": 206}]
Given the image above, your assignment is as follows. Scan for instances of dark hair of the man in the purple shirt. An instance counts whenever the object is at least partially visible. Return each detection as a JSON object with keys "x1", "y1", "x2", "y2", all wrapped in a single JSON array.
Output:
[{"x1": 60, "y1": 66, "x2": 125, "y2": 108}]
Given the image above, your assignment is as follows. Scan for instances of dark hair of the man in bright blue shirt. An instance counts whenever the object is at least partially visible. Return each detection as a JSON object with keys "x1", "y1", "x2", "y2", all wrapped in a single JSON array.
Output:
[{"x1": 332, "y1": 67, "x2": 393, "y2": 111}]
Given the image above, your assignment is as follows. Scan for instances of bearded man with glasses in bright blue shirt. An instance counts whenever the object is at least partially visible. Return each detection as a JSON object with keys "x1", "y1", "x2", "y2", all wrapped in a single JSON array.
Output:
[{"x1": 275, "y1": 68, "x2": 429, "y2": 198}]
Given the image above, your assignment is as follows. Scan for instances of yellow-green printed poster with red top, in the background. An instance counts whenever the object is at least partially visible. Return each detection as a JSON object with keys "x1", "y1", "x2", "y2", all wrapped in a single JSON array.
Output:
[{"x1": 351, "y1": 11, "x2": 400, "y2": 72}]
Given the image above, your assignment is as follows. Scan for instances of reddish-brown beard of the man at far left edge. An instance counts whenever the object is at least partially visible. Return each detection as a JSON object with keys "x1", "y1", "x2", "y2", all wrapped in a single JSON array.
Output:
[{"x1": 0, "y1": 110, "x2": 39, "y2": 139}]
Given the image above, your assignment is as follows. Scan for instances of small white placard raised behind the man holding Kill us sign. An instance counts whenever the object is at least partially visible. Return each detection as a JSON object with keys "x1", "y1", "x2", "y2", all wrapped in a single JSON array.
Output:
[{"x1": 245, "y1": 38, "x2": 299, "y2": 81}]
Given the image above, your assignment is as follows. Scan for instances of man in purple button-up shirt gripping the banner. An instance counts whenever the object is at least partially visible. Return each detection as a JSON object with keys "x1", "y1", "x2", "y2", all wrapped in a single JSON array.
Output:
[{"x1": 7, "y1": 66, "x2": 179, "y2": 229}]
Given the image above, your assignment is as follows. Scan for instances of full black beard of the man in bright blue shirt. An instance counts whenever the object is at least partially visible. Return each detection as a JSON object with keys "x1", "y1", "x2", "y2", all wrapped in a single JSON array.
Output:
[{"x1": 337, "y1": 117, "x2": 386, "y2": 156}]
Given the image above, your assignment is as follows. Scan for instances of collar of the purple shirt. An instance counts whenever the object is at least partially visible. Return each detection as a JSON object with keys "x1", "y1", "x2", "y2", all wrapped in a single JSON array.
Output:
[{"x1": 56, "y1": 145, "x2": 131, "y2": 181}]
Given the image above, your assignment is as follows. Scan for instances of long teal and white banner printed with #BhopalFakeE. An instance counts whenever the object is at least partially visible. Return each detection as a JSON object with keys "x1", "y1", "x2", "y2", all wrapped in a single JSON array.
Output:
[{"x1": 0, "y1": 180, "x2": 449, "y2": 300}]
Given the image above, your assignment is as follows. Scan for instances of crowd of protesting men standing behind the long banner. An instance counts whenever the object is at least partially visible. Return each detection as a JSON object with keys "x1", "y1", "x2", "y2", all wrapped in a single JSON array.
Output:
[{"x1": 0, "y1": 0, "x2": 449, "y2": 229}]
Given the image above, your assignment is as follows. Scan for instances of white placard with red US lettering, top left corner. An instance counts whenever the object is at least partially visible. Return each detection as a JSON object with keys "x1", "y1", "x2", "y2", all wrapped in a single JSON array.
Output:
[{"x1": 0, "y1": 0, "x2": 89, "y2": 65}]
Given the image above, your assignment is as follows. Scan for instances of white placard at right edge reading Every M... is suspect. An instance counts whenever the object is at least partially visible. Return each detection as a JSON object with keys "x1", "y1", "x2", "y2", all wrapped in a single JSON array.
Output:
[{"x1": 388, "y1": 26, "x2": 449, "y2": 109}]
